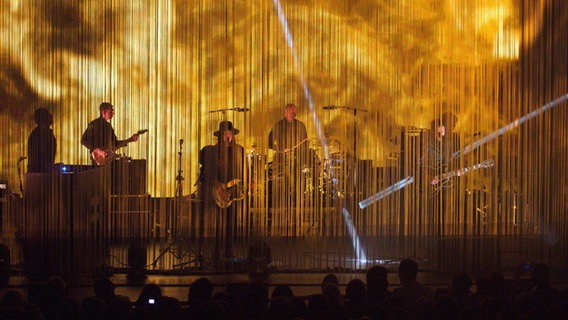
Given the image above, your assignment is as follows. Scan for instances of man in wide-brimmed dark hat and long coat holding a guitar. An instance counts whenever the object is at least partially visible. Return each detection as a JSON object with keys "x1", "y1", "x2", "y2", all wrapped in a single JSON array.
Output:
[{"x1": 199, "y1": 121, "x2": 245, "y2": 260}]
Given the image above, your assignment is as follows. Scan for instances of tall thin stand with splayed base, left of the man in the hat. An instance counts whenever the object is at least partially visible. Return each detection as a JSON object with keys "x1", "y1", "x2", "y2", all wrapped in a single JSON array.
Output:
[{"x1": 152, "y1": 139, "x2": 203, "y2": 269}]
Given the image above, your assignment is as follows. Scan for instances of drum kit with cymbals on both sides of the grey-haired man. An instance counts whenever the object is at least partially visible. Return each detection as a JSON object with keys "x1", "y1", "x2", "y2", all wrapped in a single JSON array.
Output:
[{"x1": 247, "y1": 137, "x2": 356, "y2": 198}]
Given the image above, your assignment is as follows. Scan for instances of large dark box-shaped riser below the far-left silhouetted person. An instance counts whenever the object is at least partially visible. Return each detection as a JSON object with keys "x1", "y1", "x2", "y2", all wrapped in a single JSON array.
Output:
[{"x1": 21, "y1": 167, "x2": 110, "y2": 278}]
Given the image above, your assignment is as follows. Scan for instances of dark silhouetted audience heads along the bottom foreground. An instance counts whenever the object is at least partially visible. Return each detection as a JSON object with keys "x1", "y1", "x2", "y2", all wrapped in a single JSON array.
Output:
[{"x1": 0, "y1": 259, "x2": 568, "y2": 320}]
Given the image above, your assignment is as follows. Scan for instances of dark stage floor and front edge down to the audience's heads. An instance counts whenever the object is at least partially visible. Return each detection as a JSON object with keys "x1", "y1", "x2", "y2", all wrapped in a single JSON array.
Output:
[{"x1": 0, "y1": 202, "x2": 568, "y2": 301}]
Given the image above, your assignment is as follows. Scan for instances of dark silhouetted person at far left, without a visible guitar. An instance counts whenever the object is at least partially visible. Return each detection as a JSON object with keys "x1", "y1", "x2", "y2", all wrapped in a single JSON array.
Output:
[{"x1": 28, "y1": 108, "x2": 57, "y2": 173}]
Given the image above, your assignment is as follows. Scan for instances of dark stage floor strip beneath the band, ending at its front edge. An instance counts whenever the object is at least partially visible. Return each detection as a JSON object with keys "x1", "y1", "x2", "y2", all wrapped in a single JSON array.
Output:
[{"x1": 0, "y1": 214, "x2": 568, "y2": 278}]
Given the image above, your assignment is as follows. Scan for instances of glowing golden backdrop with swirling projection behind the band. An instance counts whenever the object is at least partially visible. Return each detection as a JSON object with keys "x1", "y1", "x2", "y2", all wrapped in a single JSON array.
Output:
[{"x1": 0, "y1": 0, "x2": 568, "y2": 255}]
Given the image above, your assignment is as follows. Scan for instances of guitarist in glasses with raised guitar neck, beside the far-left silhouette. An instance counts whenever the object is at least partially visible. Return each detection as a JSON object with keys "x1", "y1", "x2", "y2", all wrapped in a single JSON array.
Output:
[{"x1": 81, "y1": 102, "x2": 138, "y2": 166}]
